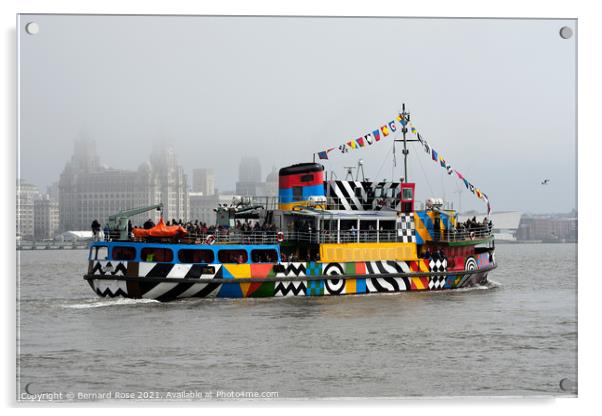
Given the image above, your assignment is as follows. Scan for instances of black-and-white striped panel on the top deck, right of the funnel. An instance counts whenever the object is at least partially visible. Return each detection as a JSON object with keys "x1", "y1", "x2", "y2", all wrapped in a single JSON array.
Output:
[{"x1": 327, "y1": 181, "x2": 401, "y2": 211}]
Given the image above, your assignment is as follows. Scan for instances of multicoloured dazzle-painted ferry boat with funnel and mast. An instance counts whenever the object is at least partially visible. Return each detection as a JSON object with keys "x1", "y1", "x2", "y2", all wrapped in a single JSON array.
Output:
[{"x1": 84, "y1": 108, "x2": 496, "y2": 301}]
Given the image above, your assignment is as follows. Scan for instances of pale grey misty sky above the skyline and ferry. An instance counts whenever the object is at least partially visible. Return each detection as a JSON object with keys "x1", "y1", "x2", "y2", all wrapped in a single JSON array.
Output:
[{"x1": 19, "y1": 15, "x2": 576, "y2": 212}]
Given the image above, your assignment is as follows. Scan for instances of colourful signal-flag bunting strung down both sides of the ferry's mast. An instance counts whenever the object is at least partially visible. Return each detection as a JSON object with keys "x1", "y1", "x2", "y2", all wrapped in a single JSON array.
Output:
[{"x1": 317, "y1": 114, "x2": 491, "y2": 215}]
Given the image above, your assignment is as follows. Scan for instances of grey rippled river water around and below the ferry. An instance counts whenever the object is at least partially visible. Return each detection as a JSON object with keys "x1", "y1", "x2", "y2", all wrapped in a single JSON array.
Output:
[{"x1": 17, "y1": 244, "x2": 577, "y2": 401}]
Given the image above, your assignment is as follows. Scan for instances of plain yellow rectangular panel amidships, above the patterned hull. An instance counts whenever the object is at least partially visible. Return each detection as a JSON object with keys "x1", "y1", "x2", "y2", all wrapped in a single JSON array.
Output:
[{"x1": 320, "y1": 243, "x2": 418, "y2": 263}]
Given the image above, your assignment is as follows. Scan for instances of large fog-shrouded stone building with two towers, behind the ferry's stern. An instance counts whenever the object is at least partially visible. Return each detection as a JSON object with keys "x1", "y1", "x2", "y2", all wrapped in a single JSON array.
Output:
[{"x1": 59, "y1": 139, "x2": 189, "y2": 231}]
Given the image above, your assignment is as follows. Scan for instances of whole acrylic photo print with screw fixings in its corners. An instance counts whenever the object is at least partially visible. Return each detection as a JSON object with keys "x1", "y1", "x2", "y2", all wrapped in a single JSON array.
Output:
[{"x1": 16, "y1": 14, "x2": 577, "y2": 402}]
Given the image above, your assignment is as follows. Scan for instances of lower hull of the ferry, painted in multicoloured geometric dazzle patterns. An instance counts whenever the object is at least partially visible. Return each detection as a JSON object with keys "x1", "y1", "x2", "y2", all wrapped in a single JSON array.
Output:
[{"x1": 84, "y1": 253, "x2": 496, "y2": 301}]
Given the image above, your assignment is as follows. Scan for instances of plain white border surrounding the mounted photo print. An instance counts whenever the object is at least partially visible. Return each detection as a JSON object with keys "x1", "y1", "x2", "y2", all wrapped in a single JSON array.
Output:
[{"x1": 0, "y1": 0, "x2": 602, "y2": 415}]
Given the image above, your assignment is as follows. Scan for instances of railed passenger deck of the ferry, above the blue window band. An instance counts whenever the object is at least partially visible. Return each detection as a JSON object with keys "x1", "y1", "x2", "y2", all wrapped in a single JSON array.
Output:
[{"x1": 106, "y1": 210, "x2": 493, "y2": 245}]
